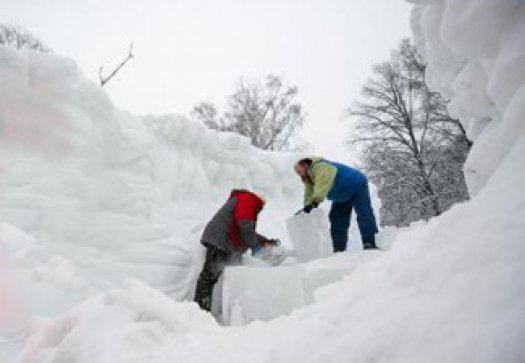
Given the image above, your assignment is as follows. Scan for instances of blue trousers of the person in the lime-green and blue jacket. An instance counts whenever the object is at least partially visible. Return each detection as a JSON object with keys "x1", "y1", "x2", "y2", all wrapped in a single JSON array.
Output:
[{"x1": 329, "y1": 183, "x2": 378, "y2": 252}]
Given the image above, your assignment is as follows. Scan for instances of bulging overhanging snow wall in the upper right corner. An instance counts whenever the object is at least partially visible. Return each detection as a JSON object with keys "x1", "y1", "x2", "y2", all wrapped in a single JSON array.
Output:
[{"x1": 409, "y1": 0, "x2": 525, "y2": 195}]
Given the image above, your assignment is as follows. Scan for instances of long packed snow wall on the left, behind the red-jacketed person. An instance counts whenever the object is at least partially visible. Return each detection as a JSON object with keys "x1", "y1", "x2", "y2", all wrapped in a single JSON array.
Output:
[{"x1": 0, "y1": 47, "x2": 302, "y2": 305}]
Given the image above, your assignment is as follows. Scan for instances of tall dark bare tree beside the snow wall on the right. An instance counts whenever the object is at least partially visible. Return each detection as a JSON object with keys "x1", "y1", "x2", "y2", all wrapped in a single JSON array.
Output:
[{"x1": 349, "y1": 40, "x2": 466, "y2": 225}]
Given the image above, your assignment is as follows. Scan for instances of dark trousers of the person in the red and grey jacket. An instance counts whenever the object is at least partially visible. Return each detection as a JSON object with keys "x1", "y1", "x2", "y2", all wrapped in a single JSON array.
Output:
[{"x1": 193, "y1": 245, "x2": 240, "y2": 311}]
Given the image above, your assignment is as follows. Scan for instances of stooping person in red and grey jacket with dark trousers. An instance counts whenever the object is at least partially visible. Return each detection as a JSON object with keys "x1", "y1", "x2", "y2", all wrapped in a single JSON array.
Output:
[{"x1": 194, "y1": 190, "x2": 275, "y2": 311}]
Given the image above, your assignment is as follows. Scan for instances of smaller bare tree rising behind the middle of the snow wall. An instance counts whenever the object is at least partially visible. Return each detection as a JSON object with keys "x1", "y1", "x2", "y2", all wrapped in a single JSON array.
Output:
[{"x1": 192, "y1": 75, "x2": 305, "y2": 150}]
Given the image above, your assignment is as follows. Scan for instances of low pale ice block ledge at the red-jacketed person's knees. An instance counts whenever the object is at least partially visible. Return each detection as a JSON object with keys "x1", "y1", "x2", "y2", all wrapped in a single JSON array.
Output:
[{"x1": 219, "y1": 250, "x2": 382, "y2": 326}]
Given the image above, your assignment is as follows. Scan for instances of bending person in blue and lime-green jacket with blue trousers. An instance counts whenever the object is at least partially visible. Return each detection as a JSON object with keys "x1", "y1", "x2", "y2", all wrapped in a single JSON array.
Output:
[{"x1": 294, "y1": 157, "x2": 378, "y2": 252}]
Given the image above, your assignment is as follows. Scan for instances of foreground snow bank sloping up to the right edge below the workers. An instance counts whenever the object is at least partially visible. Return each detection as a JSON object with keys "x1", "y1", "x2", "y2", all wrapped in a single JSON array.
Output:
[{"x1": 18, "y1": 143, "x2": 525, "y2": 363}]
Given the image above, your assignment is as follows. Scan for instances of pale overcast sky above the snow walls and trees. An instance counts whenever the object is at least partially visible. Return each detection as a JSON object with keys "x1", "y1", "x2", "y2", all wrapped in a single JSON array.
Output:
[{"x1": 0, "y1": 0, "x2": 410, "y2": 160}]
